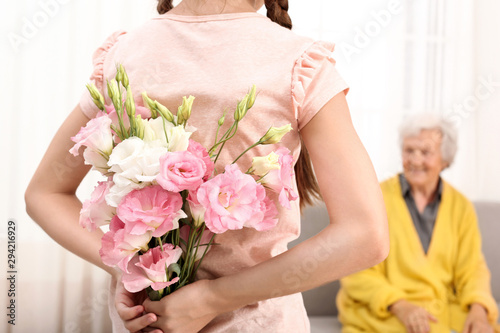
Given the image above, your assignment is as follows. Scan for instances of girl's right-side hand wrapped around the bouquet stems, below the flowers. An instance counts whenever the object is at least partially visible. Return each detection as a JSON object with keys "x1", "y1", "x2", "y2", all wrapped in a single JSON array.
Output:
[{"x1": 143, "y1": 280, "x2": 219, "y2": 333}]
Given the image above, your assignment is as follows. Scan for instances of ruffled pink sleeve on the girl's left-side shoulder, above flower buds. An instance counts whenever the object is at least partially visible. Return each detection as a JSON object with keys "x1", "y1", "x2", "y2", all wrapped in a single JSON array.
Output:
[{"x1": 80, "y1": 31, "x2": 126, "y2": 118}]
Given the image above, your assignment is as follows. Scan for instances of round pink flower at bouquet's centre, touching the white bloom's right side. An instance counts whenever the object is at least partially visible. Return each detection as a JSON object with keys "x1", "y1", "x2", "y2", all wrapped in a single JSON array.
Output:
[{"x1": 156, "y1": 151, "x2": 207, "y2": 192}]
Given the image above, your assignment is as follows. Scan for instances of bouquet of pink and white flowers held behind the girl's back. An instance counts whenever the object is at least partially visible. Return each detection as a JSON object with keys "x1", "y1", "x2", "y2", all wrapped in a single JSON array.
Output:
[{"x1": 70, "y1": 65, "x2": 297, "y2": 300}]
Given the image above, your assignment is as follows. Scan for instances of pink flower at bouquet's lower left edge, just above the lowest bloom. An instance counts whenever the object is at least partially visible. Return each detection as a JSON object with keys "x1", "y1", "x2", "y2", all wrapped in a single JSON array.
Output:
[{"x1": 99, "y1": 215, "x2": 151, "y2": 272}]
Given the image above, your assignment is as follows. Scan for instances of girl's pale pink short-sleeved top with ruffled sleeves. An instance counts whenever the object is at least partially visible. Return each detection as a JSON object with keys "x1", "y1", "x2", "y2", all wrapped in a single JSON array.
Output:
[{"x1": 80, "y1": 13, "x2": 347, "y2": 333}]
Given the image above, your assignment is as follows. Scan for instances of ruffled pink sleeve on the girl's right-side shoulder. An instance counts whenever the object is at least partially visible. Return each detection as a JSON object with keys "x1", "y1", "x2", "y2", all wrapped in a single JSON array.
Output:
[{"x1": 292, "y1": 42, "x2": 349, "y2": 130}]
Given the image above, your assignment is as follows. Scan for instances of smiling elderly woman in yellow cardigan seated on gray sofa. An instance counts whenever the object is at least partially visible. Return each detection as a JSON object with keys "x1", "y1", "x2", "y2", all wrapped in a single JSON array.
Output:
[{"x1": 337, "y1": 115, "x2": 500, "y2": 333}]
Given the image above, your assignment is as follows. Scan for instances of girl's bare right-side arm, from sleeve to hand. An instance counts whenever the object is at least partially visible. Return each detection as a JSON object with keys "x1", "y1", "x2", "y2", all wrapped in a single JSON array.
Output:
[{"x1": 144, "y1": 93, "x2": 389, "y2": 332}]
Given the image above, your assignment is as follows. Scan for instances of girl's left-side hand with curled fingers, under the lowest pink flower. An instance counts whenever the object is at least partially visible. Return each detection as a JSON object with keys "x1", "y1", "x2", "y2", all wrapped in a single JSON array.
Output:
[{"x1": 113, "y1": 277, "x2": 163, "y2": 333}]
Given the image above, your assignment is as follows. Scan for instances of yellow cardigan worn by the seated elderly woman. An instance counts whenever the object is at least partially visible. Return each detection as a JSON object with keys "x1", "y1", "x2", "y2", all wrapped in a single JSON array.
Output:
[{"x1": 337, "y1": 176, "x2": 500, "y2": 333}]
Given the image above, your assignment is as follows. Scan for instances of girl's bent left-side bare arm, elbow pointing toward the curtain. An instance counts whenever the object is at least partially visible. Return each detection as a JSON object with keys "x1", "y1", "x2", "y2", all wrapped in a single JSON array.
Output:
[{"x1": 25, "y1": 106, "x2": 114, "y2": 274}]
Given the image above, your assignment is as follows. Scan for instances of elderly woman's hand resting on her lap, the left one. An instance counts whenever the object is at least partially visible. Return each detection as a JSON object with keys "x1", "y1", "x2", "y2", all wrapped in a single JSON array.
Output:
[{"x1": 390, "y1": 300, "x2": 437, "y2": 333}]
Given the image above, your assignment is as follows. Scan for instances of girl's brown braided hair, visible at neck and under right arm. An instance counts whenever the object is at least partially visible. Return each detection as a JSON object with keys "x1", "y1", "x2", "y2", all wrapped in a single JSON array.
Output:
[{"x1": 157, "y1": 0, "x2": 322, "y2": 210}]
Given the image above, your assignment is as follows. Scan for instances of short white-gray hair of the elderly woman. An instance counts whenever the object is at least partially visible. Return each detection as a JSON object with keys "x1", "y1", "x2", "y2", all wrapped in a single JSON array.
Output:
[{"x1": 399, "y1": 113, "x2": 458, "y2": 166}]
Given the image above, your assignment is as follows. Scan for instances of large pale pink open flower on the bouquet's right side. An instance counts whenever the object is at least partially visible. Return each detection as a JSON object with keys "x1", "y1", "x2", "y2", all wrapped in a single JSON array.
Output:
[{"x1": 197, "y1": 164, "x2": 277, "y2": 234}]
